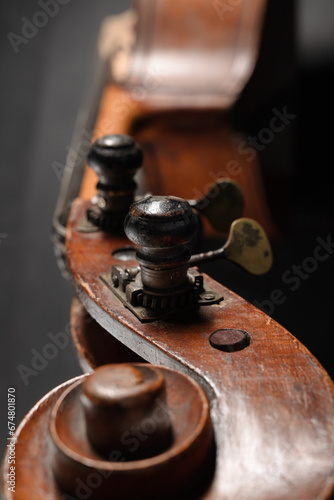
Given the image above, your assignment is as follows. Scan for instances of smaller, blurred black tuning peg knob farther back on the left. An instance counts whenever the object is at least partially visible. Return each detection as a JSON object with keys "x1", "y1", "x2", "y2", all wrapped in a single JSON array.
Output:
[{"x1": 87, "y1": 135, "x2": 143, "y2": 232}]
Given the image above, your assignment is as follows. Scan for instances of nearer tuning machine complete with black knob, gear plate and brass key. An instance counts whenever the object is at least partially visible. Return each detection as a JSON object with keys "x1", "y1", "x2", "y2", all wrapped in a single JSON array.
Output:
[{"x1": 102, "y1": 196, "x2": 272, "y2": 322}]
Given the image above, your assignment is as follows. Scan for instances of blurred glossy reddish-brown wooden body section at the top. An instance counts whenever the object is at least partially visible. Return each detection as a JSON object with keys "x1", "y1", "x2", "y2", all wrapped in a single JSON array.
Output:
[{"x1": 123, "y1": 0, "x2": 266, "y2": 108}]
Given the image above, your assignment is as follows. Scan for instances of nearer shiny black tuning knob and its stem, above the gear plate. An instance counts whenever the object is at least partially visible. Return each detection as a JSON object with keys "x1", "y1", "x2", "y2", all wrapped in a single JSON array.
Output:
[{"x1": 125, "y1": 196, "x2": 198, "y2": 289}]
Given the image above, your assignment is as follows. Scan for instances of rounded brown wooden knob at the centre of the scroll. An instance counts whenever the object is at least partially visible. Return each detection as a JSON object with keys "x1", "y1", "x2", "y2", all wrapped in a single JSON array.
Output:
[{"x1": 77, "y1": 363, "x2": 172, "y2": 458}]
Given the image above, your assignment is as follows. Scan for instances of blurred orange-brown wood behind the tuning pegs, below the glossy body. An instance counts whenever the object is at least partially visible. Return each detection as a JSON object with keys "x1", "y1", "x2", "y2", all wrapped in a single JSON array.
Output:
[{"x1": 80, "y1": 84, "x2": 279, "y2": 237}]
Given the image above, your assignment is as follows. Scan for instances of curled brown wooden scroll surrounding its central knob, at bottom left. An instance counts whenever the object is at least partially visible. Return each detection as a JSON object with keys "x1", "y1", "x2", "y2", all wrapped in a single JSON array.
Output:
[{"x1": 2, "y1": 364, "x2": 214, "y2": 500}]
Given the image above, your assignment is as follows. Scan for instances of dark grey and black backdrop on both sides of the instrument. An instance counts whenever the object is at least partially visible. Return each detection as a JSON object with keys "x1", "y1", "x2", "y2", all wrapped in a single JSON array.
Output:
[{"x1": 0, "y1": 0, "x2": 334, "y2": 476}]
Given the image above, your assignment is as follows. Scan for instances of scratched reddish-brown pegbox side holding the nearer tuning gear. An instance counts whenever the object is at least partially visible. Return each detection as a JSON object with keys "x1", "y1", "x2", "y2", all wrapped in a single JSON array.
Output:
[{"x1": 61, "y1": 200, "x2": 334, "y2": 500}]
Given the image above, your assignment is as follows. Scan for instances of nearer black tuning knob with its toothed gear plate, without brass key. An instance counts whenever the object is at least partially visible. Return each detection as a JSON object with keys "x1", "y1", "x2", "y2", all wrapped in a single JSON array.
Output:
[{"x1": 102, "y1": 196, "x2": 223, "y2": 321}]
